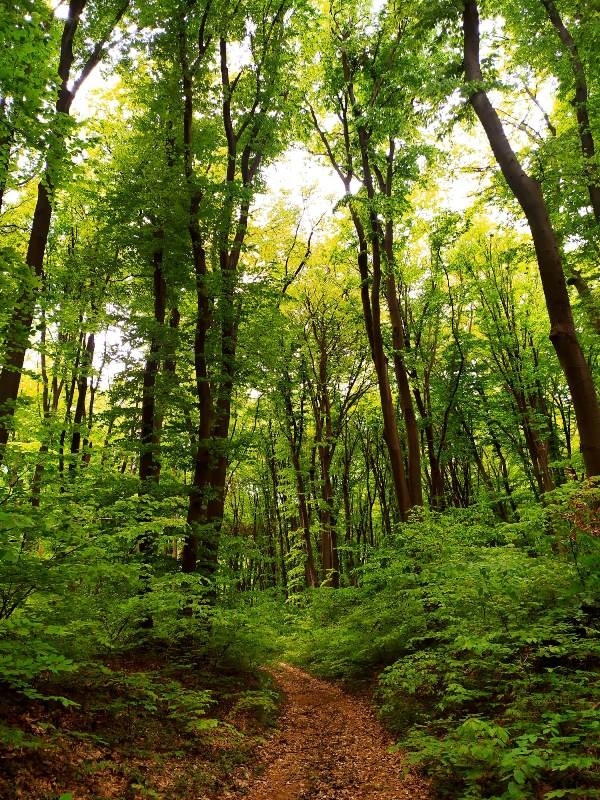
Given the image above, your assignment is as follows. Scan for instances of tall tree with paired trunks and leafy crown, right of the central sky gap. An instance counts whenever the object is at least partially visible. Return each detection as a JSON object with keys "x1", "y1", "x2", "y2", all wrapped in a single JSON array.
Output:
[{"x1": 309, "y1": 3, "x2": 422, "y2": 518}]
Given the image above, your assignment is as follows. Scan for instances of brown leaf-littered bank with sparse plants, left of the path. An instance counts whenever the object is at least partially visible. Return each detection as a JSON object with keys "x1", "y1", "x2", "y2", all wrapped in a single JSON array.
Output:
[{"x1": 0, "y1": 650, "x2": 277, "y2": 800}]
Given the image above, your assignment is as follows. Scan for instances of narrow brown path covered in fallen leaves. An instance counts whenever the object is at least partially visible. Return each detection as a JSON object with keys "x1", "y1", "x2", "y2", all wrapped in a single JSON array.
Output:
[{"x1": 226, "y1": 664, "x2": 430, "y2": 800}]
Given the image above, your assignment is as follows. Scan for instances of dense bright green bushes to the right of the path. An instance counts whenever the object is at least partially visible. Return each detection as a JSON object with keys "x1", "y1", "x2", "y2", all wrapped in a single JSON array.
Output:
[{"x1": 287, "y1": 506, "x2": 600, "y2": 800}]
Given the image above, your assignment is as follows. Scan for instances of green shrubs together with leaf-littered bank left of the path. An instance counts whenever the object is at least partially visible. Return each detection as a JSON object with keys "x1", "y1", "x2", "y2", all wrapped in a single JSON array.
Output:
[{"x1": 0, "y1": 482, "x2": 278, "y2": 800}]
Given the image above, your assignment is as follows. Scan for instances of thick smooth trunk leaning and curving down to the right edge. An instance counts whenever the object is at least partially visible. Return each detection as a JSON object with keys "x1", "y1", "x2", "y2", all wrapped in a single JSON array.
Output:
[{"x1": 463, "y1": 0, "x2": 600, "y2": 476}]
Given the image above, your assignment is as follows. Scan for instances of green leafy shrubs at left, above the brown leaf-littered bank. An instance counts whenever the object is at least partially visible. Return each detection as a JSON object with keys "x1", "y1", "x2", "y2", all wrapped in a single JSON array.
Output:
[{"x1": 0, "y1": 476, "x2": 209, "y2": 705}]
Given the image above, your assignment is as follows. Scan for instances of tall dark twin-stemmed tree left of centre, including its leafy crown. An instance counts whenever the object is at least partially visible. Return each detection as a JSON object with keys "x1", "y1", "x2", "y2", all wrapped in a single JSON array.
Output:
[{"x1": 179, "y1": 0, "x2": 300, "y2": 581}]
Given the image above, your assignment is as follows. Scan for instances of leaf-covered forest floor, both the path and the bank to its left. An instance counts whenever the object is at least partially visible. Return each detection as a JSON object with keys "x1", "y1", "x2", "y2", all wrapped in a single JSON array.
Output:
[{"x1": 0, "y1": 653, "x2": 430, "y2": 800}]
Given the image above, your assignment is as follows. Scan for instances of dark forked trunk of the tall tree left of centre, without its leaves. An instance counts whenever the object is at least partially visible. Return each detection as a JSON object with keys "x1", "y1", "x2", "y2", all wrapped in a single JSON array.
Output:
[{"x1": 180, "y1": 25, "x2": 274, "y2": 584}]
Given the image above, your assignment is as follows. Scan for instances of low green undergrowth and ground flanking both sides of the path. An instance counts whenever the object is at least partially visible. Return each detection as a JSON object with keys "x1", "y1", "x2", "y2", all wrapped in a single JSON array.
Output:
[{"x1": 0, "y1": 472, "x2": 600, "y2": 800}]
